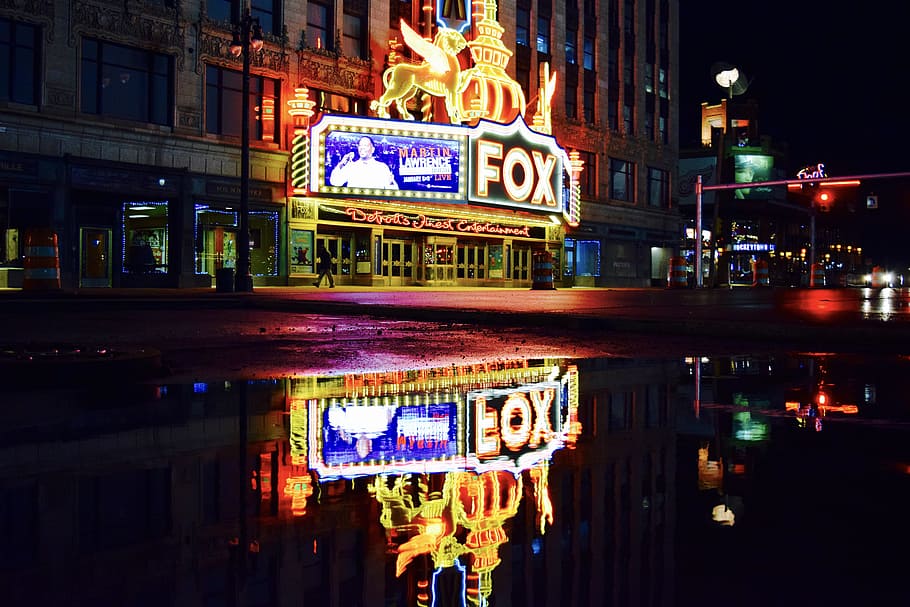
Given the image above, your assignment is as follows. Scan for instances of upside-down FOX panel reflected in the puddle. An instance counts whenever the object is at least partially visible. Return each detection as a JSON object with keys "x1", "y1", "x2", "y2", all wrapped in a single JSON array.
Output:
[{"x1": 467, "y1": 381, "x2": 565, "y2": 469}]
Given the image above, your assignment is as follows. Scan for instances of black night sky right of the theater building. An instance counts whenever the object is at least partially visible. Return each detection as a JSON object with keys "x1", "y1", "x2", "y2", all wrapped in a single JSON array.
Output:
[{"x1": 679, "y1": 0, "x2": 910, "y2": 176}]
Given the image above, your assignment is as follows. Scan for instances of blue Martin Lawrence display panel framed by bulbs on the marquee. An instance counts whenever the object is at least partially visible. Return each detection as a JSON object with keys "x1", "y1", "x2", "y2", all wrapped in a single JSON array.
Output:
[{"x1": 310, "y1": 115, "x2": 467, "y2": 202}]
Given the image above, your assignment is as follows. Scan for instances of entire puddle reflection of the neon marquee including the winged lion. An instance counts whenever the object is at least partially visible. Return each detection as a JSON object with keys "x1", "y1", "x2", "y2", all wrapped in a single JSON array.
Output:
[{"x1": 284, "y1": 360, "x2": 581, "y2": 605}]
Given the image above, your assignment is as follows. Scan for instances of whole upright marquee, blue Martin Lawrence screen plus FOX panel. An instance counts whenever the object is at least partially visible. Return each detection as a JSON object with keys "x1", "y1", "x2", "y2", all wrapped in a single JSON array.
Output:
[{"x1": 310, "y1": 114, "x2": 569, "y2": 215}]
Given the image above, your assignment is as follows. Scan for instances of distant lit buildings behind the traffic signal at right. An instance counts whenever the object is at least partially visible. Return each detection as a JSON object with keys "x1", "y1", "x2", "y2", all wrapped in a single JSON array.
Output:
[{"x1": 678, "y1": 98, "x2": 871, "y2": 286}]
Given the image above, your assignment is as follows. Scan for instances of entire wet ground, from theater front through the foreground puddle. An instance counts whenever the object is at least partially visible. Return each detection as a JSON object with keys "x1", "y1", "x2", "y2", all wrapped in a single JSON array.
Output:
[{"x1": 0, "y1": 288, "x2": 910, "y2": 607}]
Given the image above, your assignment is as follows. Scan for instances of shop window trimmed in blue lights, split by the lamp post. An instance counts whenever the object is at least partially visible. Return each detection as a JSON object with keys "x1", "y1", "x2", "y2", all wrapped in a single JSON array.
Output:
[{"x1": 194, "y1": 204, "x2": 279, "y2": 276}]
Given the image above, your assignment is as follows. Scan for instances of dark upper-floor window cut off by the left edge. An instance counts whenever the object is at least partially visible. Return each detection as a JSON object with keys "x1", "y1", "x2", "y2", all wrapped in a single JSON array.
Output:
[{"x1": 0, "y1": 19, "x2": 41, "y2": 105}]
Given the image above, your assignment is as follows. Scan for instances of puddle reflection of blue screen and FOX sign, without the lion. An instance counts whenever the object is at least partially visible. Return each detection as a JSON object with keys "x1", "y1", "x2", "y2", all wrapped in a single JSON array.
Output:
[{"x1": 290, "y1": 358, "x2": 578, "y2": 482}]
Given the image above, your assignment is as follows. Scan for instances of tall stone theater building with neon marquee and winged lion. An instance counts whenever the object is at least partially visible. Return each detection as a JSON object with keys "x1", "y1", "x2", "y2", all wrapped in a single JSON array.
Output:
[{"x1": 0, "y1": 0, "x2": 682, "y2": 288}]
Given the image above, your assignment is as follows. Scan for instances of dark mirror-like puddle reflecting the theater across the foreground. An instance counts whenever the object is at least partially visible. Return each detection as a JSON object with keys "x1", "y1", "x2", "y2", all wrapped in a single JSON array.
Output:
[{"x1": 0, "y1": 352, "x2": 910, "y2": 607}]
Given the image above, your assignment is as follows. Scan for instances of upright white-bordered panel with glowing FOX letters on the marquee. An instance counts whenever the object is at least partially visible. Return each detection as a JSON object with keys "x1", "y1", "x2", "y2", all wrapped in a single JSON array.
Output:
[{"x1": 468, "y1": 118, "x2": 569, "y2": 213}]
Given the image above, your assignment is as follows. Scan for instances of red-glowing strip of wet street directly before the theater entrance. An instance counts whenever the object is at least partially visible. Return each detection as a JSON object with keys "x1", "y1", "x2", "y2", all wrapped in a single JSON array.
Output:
[{"x1": 0, "y1": 286, "x2": 910, "y2": 350}]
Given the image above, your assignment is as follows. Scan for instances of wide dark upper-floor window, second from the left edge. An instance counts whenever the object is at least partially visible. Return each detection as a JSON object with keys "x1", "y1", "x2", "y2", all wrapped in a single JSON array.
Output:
[{"x1": 80, "y1": 38, "x2": 174, "y2": 126}]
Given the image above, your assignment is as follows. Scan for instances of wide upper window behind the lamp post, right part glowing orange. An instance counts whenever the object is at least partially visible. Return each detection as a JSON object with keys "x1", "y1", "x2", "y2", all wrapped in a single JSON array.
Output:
[{"x1": 205, "y1": 65, "x2": 281, "y2": 142}]
